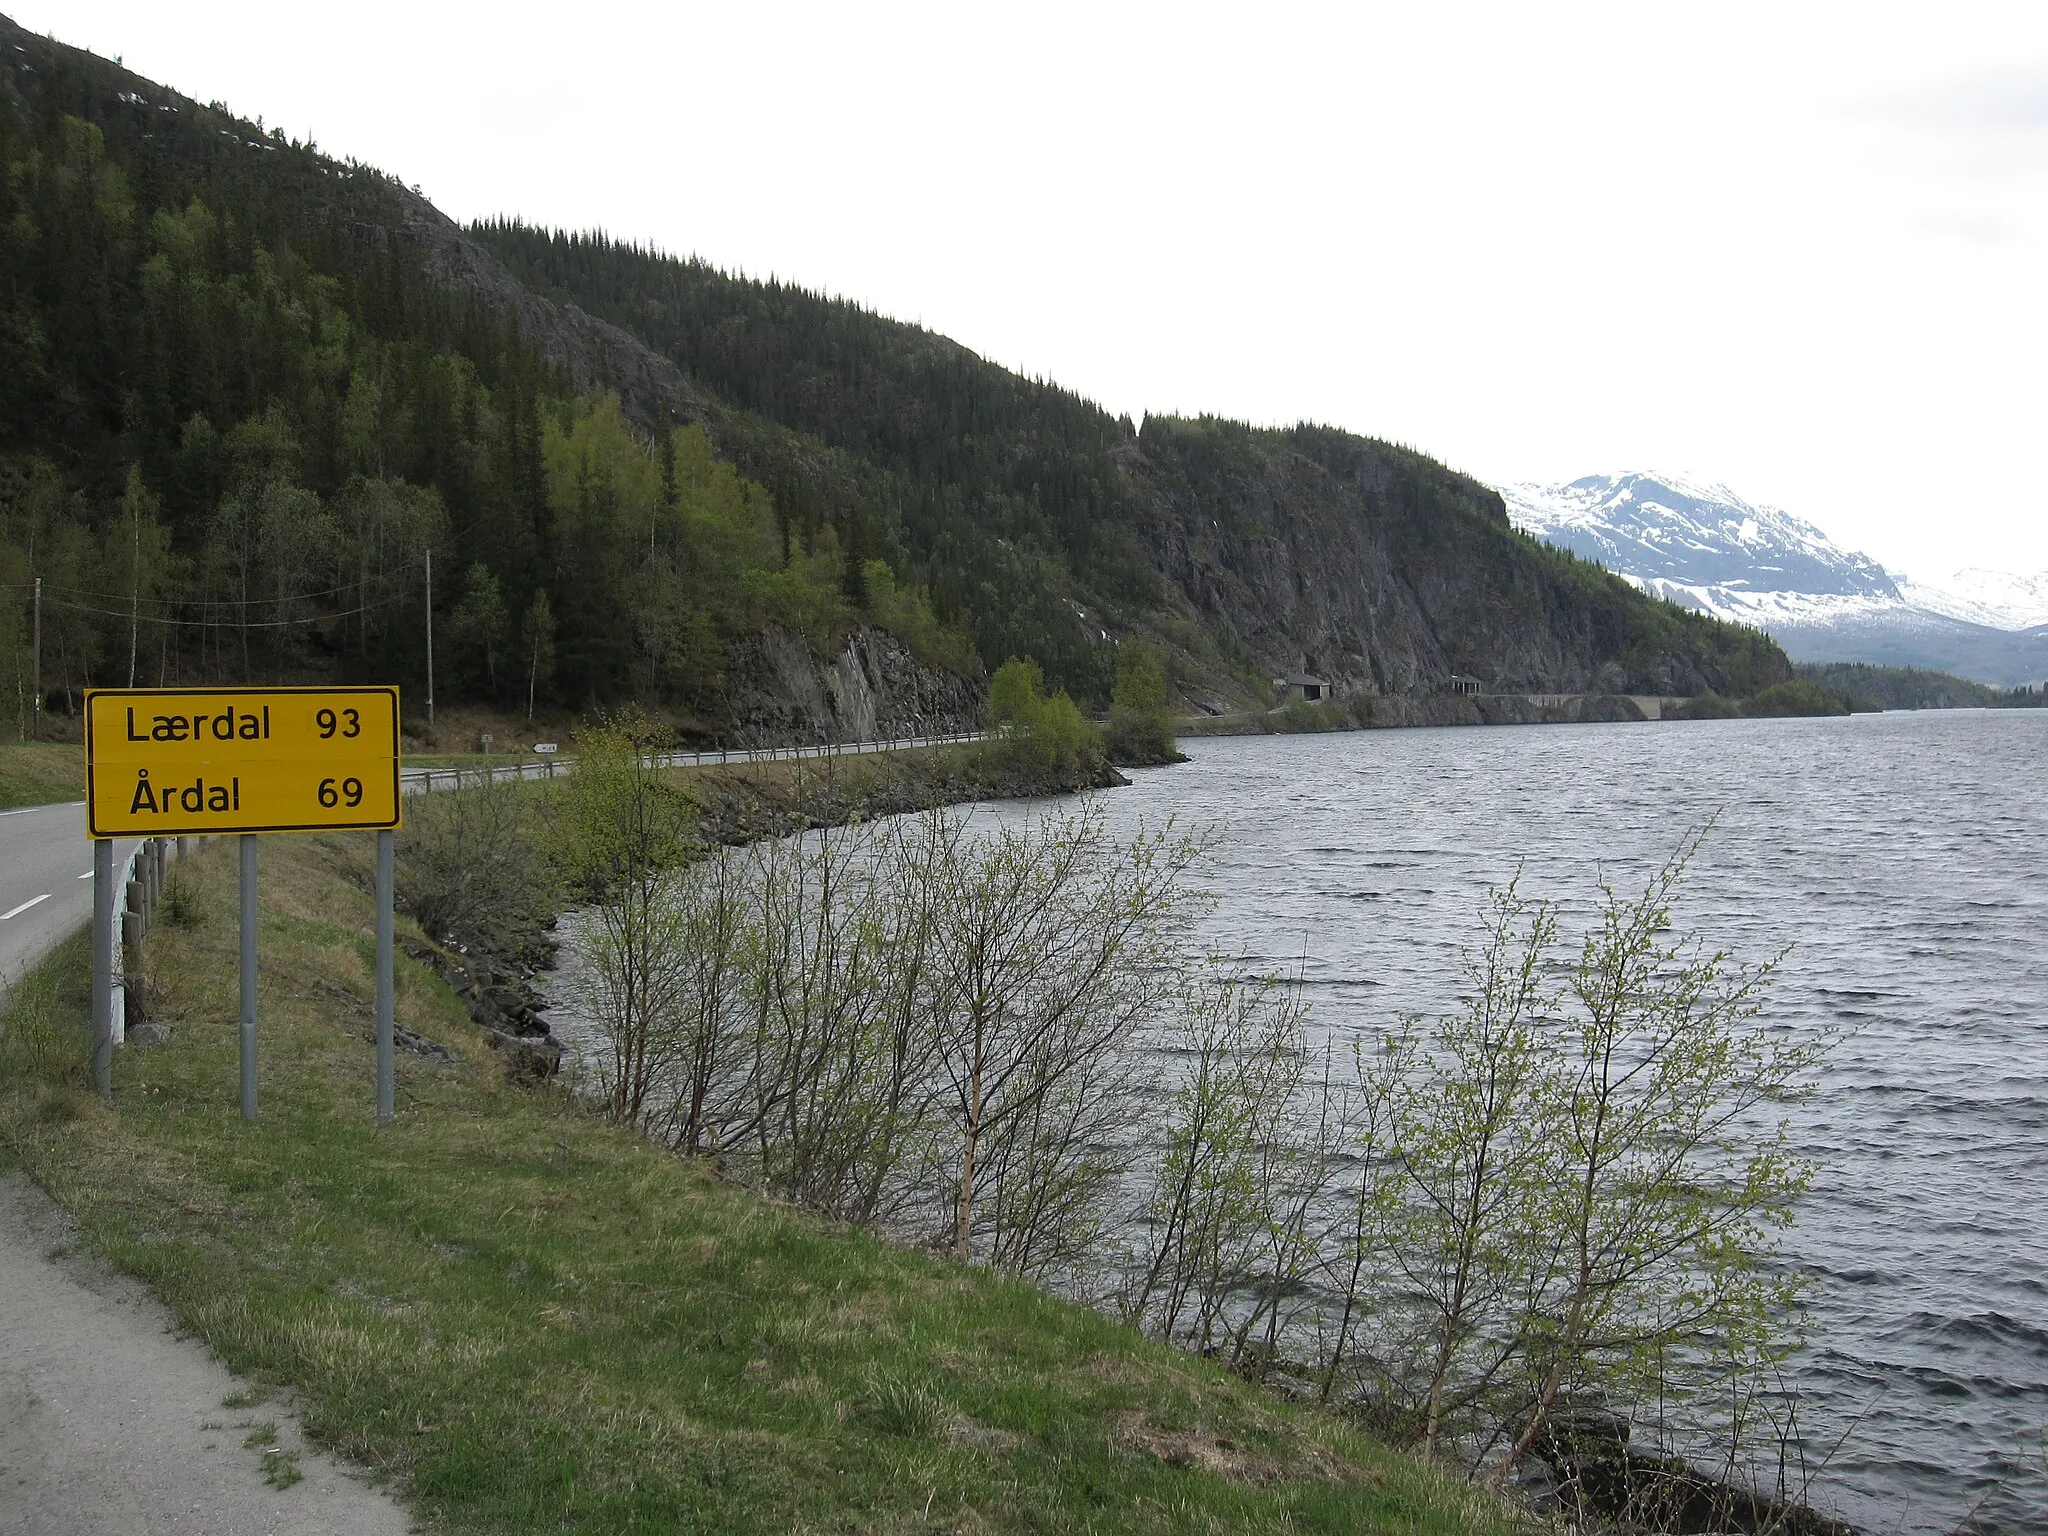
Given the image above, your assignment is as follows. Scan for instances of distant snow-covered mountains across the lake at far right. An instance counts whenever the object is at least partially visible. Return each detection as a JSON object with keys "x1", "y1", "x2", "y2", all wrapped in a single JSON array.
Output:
[{"x1": 1497, "y1": 473, "x2": 2048, "y2": 688}]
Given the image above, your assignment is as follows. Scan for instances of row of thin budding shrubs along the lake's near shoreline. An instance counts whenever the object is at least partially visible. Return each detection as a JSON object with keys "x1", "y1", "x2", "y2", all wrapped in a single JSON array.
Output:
[{"x1": 499, "y1": 729, "x2": 1821, "y2": 1530}]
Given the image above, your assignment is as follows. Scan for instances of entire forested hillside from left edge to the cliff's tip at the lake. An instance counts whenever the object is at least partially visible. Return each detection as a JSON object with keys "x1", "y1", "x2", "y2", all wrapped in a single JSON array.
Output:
[{"x1": 0, "y1": 20, "x2": 1786, "y2": 733}]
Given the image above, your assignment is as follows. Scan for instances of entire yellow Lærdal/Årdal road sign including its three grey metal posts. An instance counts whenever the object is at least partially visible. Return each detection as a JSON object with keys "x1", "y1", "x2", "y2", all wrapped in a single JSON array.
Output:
[{"x1": 86, "y1": 688, "x2": 399, "y2": 1122}]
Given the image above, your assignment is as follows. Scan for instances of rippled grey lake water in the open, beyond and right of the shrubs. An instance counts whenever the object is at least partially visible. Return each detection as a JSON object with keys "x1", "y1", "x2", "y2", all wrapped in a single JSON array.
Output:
[{"x1": 970, "y1": 711, "x2": 2048, "y2": 1536}]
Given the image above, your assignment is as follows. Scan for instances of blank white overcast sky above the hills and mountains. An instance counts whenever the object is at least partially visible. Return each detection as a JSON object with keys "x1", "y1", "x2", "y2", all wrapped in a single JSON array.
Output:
[{"x1": 19, "y1": 0, "x2": 2048, "y2": 578}]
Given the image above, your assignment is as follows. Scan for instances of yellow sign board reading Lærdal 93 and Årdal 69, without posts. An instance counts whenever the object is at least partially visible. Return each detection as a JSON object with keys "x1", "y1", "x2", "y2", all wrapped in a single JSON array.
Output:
[{"x1": 86, "y1": 688, "x2": 399, "y2": 838}]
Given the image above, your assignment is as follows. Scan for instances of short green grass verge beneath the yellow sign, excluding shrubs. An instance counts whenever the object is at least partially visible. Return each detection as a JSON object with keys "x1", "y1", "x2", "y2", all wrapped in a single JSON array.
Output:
[{"x1": 0, "y1": 838, "x2": 1511, "y2": 1534}]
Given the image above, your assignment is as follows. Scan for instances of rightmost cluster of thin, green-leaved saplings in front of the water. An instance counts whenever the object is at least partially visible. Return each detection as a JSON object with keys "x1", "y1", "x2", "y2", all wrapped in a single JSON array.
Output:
[{"x1": 1124, "y1": 840, "x2": 1823, "y2": 1483}]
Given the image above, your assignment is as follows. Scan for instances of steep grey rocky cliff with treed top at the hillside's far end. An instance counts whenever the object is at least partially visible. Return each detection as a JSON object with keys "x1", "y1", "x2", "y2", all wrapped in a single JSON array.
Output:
[{"x1": 1122, "y1": 418, "x2": 1790, "y2": 708}]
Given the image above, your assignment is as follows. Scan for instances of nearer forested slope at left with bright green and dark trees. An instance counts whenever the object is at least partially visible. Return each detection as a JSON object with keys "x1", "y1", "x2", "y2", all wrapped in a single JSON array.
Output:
[{"x1": 0, "y1": 18, "x2": 975, "y2": 741}]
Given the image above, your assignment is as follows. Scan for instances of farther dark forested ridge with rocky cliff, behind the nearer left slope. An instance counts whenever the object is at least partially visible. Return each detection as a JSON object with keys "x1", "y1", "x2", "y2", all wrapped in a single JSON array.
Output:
[{"x1": 469, "y1": 221, "x2": 1790, "y2": 698}]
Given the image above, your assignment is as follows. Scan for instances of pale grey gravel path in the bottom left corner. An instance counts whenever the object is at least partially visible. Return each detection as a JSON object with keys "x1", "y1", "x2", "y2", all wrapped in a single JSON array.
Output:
[{"x1": 0, "y1": 1169, "x2": 414, "y2": 1536}]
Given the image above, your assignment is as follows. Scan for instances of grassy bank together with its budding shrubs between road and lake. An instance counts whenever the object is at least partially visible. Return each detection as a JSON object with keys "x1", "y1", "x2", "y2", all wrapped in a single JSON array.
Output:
[{"x1": 0, "y1": 716, "x2": 1827, "y2": 1532}]
